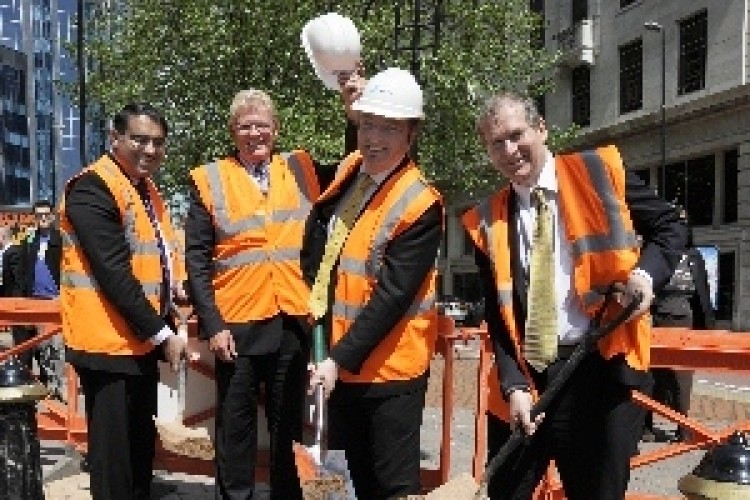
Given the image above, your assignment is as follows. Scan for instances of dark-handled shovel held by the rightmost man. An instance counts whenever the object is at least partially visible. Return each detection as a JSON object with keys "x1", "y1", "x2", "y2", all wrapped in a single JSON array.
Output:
[{"x1": 474, "y1": 285, "x2": 643, "y2": 500}]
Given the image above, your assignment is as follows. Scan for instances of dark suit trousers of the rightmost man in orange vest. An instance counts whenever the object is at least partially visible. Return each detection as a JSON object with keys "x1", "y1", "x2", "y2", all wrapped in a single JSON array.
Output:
[{"x1": 487, "y1": 353, "x2": 645, "y2": 500}]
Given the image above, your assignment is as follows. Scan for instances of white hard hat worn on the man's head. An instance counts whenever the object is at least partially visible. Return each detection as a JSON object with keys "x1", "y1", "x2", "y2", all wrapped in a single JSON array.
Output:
[{"x1": 352, "y1": 68, "x2": 424, "y2": 119}]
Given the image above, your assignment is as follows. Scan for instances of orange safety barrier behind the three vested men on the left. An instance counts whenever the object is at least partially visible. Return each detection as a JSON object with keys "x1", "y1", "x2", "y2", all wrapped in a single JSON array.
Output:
[{"x1": 0, "y1": 298, "x2": 462, "y2": 491}]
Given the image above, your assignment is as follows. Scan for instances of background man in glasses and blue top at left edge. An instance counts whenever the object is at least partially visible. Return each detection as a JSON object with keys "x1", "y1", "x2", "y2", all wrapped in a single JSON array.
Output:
[{"x1": 6, "y1": 200, "x2": 63, "y2": 386}]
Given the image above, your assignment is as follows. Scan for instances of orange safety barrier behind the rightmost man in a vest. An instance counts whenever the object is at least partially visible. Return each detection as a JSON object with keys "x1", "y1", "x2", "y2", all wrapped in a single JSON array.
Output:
[{"x1": 470, "y1": 322, "x2": 750, "y2": 500}]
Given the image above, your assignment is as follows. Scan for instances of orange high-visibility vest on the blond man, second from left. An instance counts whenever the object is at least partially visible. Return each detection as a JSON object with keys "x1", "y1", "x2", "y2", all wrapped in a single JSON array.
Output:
[{"x1": 190, "y1": 151, "x2": 320, "y2": 323}]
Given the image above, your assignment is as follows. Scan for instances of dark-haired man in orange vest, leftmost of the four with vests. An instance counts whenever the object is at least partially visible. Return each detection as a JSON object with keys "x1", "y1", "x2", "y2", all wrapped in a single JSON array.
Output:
[{"x1": 60, "y1": 103, "x2": 191, "y2": 500}]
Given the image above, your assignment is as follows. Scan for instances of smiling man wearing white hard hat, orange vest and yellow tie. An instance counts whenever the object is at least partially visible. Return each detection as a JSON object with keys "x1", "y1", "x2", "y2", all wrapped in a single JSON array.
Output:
[{"x1": 302, "y1": 68, "x2": 443, "y2": 500}]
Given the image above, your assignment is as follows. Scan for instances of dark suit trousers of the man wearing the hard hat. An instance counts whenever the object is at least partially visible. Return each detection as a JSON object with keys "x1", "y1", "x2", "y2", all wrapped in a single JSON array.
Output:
[{"x1": 328, "y1": 388, "x2": 426, "y2": 500}]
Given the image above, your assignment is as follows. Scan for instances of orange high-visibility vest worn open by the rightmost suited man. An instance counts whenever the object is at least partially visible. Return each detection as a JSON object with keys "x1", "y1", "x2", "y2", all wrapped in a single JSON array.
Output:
[{"x1": 462, "y1": 146, "x2": 650, "y2": 419}]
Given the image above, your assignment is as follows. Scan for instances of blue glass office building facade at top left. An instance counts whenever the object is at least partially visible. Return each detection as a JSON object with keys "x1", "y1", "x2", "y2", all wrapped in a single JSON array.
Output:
[{"x1": 0, "y1": 0, "x2": 90, "y2": 208}]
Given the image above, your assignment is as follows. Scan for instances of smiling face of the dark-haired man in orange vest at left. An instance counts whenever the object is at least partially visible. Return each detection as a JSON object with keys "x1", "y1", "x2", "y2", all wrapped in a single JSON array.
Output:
[{"x1": 110, "y1": 115, "x2": 166, "y2": 179}]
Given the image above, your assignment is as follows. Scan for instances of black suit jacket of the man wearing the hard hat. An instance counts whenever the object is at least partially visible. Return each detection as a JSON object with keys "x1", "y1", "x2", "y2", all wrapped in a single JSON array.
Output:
[{"x1": 301, "y1": 156, "x2": 443, "y2": 385}]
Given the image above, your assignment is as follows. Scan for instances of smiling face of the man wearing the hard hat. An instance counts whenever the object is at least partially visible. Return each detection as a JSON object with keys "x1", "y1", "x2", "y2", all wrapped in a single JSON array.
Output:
[{"x1": 357, "y1": 113, "x2": 418, "y2": 174}]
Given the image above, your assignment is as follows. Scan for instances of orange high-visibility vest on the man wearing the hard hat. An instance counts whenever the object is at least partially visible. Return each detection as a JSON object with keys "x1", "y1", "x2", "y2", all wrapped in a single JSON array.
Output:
[{"x1": 321, "y1": 152, "x2": 441, "y2": 383}]
